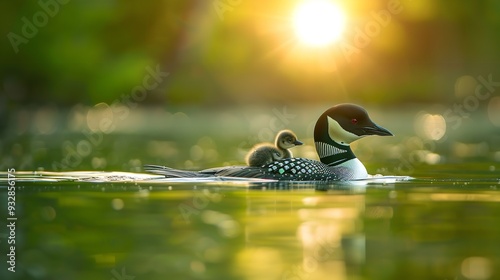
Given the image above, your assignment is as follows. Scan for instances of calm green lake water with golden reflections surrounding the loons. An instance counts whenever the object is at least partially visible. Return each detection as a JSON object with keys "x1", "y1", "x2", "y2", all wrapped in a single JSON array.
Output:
[{"x1": 0, "y1": 108, "x2": 500, "y2": 280}]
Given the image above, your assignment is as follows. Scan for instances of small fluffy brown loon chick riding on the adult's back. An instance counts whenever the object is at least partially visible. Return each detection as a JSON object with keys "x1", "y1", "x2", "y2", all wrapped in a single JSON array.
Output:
[{"x1": 246, "y1": 130, "x2": 304, "y2": 166}]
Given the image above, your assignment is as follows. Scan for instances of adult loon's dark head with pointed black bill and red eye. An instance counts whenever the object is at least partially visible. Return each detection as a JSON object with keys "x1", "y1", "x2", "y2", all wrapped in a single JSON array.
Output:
[{"x1": 314, "y1": 103, "x2": 393, "y2": 145}]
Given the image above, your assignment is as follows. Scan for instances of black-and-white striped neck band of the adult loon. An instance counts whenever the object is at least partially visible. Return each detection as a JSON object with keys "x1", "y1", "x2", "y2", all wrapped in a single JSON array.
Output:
[{"x1": 315, "y1": 140, "x2": 356, "y2": 166}]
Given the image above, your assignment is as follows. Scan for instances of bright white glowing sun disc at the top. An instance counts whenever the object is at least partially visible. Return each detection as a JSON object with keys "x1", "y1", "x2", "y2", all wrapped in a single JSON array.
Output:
[{"x1": 293, "y1": 0, "x2": 345, "y2": 47}]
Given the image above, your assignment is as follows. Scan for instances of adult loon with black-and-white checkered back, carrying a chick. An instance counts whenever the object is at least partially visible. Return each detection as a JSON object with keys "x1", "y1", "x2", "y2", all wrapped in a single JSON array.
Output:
[{"x1": 144, "y1": 104, "x2": 393, "y2": 181}]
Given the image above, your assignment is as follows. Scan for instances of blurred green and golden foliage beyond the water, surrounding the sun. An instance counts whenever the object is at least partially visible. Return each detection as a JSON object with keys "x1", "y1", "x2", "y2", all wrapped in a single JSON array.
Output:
[{"x1": 0, "y1": 0, "x2": 500, "y2": 109}]
